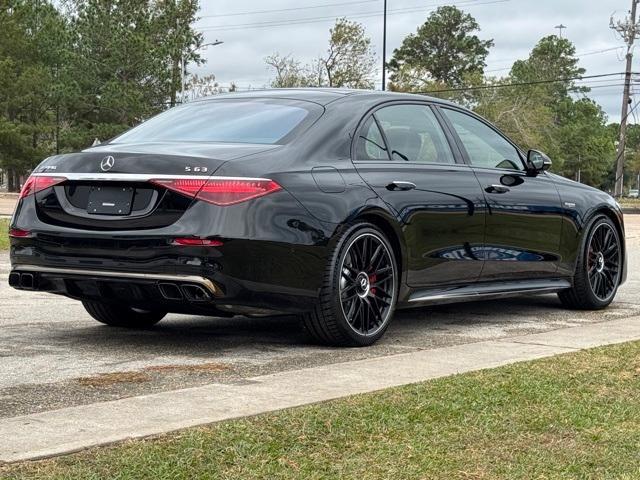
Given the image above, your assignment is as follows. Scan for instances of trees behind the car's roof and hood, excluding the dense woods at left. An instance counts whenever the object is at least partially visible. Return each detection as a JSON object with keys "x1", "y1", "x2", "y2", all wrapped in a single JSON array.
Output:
[{"x1": 265, "y1": 6, "x2": 640, "y2": 190}]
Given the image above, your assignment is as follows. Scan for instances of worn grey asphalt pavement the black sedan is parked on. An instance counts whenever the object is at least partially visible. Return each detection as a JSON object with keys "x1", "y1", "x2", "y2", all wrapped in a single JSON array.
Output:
[{"x1": 0, "y1": 215, "x2": 640, "y2": 417}]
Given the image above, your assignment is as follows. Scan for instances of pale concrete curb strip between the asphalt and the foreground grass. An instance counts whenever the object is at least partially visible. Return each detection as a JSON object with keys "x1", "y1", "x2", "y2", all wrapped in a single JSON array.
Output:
[{"x1": 0, "y1": 317, "x2": 640, "y2": 462}]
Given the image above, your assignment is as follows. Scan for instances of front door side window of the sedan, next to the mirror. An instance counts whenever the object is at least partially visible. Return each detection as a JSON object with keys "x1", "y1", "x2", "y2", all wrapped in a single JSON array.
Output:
[{"x1": 442, "y1": 108, "x2": 522, "y2": 170}]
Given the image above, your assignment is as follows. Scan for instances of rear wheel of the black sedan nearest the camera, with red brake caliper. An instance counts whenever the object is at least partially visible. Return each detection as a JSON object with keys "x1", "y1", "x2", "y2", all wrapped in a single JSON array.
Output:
[{"x1": 303, "y1": 223, "x2": 399, "y2": 347}]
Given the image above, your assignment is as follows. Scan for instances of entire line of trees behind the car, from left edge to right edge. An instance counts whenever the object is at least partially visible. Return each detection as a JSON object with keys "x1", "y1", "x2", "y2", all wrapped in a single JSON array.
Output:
[{"x1": 0, "y1": 0, "x2": 640, "y2": 190}]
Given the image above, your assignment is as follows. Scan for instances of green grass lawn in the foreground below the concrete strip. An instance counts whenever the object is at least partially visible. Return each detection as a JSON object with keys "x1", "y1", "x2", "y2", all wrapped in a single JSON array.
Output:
[{"x1": 0, "y1": 342, "x2": 640, "y2": 480}]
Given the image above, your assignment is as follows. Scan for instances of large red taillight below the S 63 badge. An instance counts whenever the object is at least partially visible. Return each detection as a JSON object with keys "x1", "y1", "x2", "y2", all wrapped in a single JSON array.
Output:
[{"x1": 151, "y1": 178, "x2": 282, "y2": 206}]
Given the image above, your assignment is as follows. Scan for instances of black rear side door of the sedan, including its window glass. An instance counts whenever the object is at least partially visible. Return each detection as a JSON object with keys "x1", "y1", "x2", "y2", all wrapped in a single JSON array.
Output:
[{"x1": 353, "y1": 103, "x2": 484, "y2": 287}]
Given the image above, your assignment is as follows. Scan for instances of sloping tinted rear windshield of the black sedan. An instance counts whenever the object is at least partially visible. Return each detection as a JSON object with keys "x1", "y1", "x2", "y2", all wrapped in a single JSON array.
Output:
[{"x1": 111, "y1": 99, "x2": 323, "y2": 144}]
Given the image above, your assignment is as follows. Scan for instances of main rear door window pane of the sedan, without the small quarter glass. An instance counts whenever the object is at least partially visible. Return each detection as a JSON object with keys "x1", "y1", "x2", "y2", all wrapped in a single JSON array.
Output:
[{"x1": 375, "y1": 105, "x2": 455, "y2": 163}]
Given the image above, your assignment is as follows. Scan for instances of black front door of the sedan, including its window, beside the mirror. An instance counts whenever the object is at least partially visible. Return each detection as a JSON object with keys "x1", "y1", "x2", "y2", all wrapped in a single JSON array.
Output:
[{"x1": 441, "y1": 107, "x2": 562, "y2": 280}]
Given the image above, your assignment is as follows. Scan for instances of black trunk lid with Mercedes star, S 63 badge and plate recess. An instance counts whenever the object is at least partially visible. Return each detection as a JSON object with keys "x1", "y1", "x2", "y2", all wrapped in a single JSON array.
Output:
[{"x1": 34, "y1": 143, "x2": 278, "y2": 230}]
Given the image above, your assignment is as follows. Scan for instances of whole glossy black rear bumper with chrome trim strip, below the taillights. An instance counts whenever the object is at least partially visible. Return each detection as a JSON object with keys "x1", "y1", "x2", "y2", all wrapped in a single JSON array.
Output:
[{"x1": 10, "y1": 192, "x2": 336, "y2": 313}]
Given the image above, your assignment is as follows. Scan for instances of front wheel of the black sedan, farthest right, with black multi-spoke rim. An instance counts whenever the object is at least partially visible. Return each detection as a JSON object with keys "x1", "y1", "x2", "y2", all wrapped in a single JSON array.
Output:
[{"x1": 558, "y1": 215, "x2": 622, "y2": 310}]
